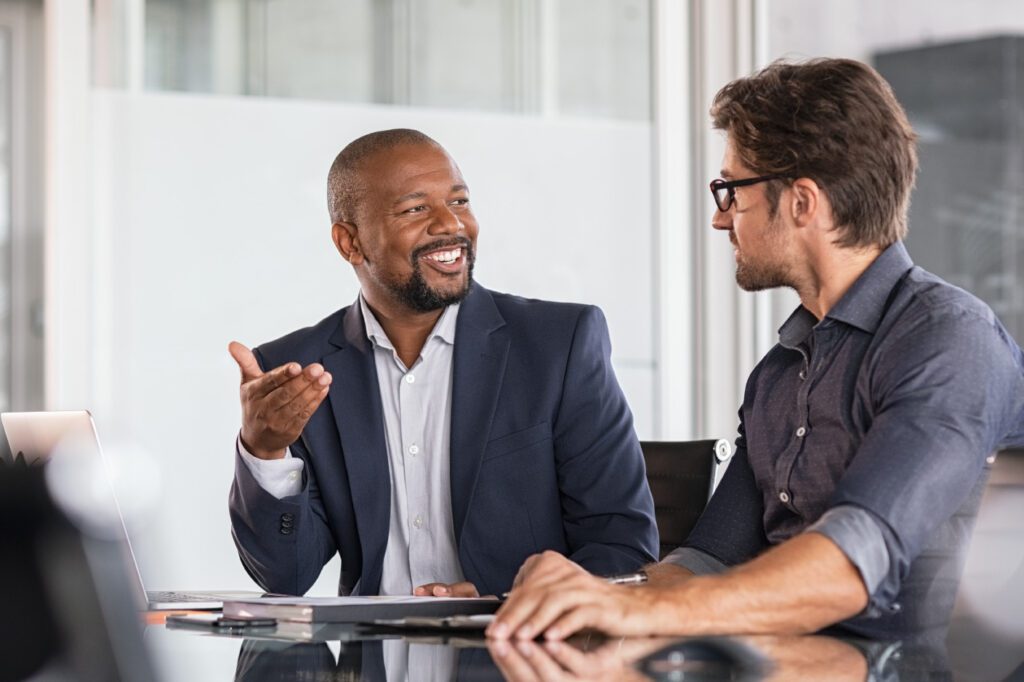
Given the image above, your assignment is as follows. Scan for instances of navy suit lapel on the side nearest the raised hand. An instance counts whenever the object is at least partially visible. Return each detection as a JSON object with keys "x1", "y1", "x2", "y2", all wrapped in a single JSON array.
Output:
[{"x1": 324, "y1": 302, "x2": 391, "y2": 594}]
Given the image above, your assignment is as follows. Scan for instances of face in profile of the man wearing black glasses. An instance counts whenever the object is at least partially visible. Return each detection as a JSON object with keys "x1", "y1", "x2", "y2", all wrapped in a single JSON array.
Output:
[{"x1": 712, "y1": 138, "x2": 796, "y2": 291}]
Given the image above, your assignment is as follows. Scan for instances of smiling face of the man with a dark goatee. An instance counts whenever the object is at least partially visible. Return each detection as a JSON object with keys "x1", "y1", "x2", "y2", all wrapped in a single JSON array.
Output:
[{"x1": 335, "y1": 143, "x2": 478, "y2": 313}]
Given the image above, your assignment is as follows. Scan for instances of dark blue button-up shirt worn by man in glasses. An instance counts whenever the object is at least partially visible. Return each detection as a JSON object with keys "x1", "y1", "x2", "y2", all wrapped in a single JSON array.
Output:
[{"x1": 679, "y1": 243, "x2": 1024, "y2": 636}]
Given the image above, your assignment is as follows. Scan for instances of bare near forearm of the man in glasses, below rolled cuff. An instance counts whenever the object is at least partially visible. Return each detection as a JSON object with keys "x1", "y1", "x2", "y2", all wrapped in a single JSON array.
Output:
[{"x1": 642, "y1": 534, "x2": 868, "y2": 635}]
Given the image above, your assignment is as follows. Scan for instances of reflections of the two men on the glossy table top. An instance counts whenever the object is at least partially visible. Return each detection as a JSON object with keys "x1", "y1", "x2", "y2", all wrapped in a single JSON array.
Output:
[{"x1": 146, "y1": 626, "x2": 966, "y2": 682}]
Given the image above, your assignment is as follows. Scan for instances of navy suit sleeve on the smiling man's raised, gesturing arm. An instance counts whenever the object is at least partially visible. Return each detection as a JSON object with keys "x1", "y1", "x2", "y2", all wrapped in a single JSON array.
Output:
[{"x1": 228, "y1": 351, "x2": 336, "y2": 595}]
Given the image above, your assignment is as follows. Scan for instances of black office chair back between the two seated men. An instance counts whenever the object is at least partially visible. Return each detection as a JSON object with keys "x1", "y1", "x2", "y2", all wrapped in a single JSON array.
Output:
[{"x1": 640, "y1": 438, "x2": 732, "y2": 559}]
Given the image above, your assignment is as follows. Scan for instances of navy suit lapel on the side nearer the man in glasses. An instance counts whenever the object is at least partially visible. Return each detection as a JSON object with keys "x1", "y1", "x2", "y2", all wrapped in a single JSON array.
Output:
[{"x1": 451, "y1": 284, "x2": 509, "y2": 544}]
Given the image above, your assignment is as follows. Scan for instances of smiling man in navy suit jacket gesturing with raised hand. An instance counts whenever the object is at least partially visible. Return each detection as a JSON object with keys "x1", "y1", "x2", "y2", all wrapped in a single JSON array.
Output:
[{"x1": 229, "y1": 129, "x2": 657, "y2": 596}]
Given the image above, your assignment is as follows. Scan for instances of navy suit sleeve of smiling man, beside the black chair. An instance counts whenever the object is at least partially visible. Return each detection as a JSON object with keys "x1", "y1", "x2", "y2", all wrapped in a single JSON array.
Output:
[{"x1": 554, "y1": 306, "x2": 657, "y2": 574}]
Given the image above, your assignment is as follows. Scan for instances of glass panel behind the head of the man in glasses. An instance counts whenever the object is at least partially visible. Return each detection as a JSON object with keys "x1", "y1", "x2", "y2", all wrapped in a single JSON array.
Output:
[{"x1": 768, "y1": 0, "x2": 1024, "y2": 341}]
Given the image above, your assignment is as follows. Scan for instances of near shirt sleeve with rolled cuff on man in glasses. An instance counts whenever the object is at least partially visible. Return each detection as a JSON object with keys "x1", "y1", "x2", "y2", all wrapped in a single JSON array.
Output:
[{"x1": 819, "y1": 307, "x2": 1024, "y2": 605}]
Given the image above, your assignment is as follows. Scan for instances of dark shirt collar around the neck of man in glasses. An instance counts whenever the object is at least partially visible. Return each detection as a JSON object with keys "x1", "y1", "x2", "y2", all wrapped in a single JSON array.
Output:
[{"x1": 778, "y1": 242, "x2": 913, "y2": 348}]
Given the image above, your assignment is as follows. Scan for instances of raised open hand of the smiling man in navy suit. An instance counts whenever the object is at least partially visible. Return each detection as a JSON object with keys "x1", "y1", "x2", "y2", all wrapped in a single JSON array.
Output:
[{"x1": 227, "y1": 341, "x2": 331, "y2": 460}]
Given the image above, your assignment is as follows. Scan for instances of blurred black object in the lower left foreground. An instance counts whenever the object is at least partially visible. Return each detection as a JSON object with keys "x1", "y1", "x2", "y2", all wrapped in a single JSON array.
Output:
[{"x1": 0, "y1": 461, "x2": 155, "y2": 682}]
